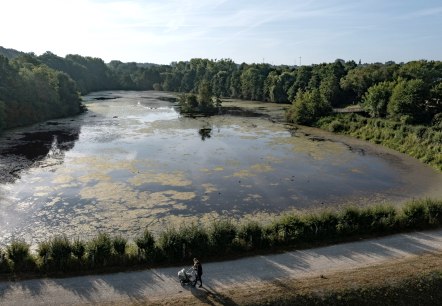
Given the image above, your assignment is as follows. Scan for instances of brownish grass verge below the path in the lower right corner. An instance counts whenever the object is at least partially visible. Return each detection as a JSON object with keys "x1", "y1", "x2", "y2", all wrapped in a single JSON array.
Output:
[{"x1": 230, "y1": 253, "x2": 442, "y2": 306}]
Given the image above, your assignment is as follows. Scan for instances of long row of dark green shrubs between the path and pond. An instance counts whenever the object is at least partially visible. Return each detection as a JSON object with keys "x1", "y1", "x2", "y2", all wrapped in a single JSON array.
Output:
[{"x1": 0, "y1": 199, "x2": 442, "y2": 278}]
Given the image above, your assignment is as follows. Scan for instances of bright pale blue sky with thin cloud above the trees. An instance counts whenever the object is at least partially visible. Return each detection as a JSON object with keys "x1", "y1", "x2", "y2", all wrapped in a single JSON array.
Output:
[{"x1": 0, "y1": 0, "x2": 442, "y2": 65}]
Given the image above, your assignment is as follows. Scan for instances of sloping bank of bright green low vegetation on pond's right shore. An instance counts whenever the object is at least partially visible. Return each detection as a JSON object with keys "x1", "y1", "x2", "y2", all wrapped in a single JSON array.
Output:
[{"x1": 316, "y1": 114, "x2": 442, "y2": 171}]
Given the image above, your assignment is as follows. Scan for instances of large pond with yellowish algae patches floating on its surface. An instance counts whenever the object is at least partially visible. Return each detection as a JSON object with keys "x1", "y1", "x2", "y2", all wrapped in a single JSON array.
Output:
[{"x1": 0, "y1": 91, "x2": 442, "y2": 245}]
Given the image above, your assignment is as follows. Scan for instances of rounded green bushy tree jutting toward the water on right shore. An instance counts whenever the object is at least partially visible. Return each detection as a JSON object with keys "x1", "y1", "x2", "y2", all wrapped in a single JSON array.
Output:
[{"x1": 287, "y1": 89, "x2": 332, "y2": 125}]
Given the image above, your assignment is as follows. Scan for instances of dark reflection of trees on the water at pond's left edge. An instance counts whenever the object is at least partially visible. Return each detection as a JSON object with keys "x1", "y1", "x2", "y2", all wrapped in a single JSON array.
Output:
[{"x1": 0, "y1": 126, "x2": 80, "y2": 183}]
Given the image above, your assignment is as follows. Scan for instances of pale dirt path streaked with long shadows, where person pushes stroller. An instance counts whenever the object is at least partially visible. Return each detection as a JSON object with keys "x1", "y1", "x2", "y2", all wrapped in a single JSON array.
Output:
[{"x1": 0, "y1": 229, "x2": 442, "y2": 305}]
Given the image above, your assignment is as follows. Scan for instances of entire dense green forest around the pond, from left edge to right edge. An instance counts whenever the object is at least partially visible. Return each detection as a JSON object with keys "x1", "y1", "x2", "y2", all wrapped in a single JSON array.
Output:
[{"x1": 0, "y1": 48, "x2": 442, "y2": 134}]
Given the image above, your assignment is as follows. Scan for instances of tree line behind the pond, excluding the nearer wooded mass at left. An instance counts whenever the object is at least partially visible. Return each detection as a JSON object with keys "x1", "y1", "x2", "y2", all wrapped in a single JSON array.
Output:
[{"x1": 39, "y1": 52, "x2": 442, "y2": 124}]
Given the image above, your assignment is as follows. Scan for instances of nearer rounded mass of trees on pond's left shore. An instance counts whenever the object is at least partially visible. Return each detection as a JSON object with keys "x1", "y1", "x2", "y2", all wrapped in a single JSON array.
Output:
[{"x1": 0, "y1": 55, "x2": 83, "y2": 131}]
